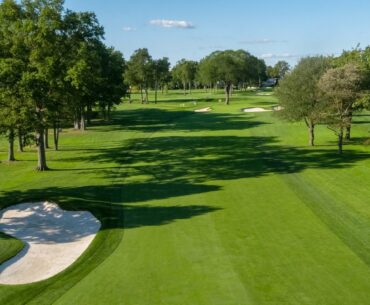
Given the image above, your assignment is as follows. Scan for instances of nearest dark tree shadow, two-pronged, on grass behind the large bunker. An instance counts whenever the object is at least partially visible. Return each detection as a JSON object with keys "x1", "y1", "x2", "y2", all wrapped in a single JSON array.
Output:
[{"x1": 0, "y1": 183, "x2": 219, "y2": 234}]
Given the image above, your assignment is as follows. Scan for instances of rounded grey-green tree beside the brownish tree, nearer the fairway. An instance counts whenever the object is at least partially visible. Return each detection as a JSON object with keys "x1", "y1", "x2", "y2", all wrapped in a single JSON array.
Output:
[{"x1": 275, "y1": 56, "x2": 330, "y2": 146}]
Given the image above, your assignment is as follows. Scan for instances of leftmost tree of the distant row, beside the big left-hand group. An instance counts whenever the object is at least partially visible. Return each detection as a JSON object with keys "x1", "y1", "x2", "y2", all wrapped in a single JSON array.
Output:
[{"x1": 125, "y1": 48, "x2": 153, "y2": 103}]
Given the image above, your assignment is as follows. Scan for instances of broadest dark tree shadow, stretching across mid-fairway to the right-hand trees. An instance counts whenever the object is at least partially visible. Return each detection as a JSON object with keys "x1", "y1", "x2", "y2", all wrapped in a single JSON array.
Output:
[{"x1": 77, "y1": 136, "x2": 370, "y2": 183}]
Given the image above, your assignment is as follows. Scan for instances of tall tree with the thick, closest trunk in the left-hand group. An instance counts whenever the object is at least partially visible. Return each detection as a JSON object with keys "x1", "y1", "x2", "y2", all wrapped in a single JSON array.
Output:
[{"x1": 21, "y1": 0, "x2": 68, "y2": 171}]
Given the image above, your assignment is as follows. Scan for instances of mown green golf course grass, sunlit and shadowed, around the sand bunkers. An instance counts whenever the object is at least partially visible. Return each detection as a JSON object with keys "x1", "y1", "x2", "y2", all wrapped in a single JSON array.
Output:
[{"x1": 0, "y1": 91, "x2": 370, "y2": 305}]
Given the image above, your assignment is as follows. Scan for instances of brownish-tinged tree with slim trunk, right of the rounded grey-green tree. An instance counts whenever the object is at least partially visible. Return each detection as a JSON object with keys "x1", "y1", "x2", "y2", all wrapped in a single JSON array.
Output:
[{"x1": 318, "y1": 64, "x2": 364, "y2": 154}]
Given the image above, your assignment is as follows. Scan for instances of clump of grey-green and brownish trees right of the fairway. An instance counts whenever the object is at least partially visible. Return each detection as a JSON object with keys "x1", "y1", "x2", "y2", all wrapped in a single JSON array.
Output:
[{"x1": 276, "y1": 47, "x2": 370, "y2": 154}]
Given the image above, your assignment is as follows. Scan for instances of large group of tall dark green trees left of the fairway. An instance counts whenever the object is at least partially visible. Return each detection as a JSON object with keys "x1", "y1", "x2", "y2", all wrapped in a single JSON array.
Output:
[{"x1": 0, "y1": 0, "x2": 126, "y2": 171}]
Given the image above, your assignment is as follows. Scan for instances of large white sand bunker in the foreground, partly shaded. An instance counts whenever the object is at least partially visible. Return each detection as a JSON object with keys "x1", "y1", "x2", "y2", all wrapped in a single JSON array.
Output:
[{"x1": 0, "y1": 202, "x2": 100, "y2": 285}]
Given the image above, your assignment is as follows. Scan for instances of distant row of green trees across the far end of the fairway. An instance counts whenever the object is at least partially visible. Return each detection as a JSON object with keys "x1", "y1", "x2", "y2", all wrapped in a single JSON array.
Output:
[{"x1": 125, "y1": 48, "x2": 290, "y2": 104}]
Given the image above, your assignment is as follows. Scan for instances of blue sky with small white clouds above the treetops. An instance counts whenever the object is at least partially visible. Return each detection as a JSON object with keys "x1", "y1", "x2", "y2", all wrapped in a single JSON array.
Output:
[{"x1": 66, "y1": 0, "x2": 370, "y2": 65}]
